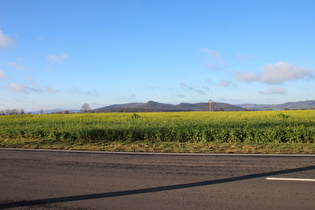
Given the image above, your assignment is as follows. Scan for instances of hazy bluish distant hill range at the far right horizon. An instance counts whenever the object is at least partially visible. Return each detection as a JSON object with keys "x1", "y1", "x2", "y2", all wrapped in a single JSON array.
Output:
[{"x1": 237, "y1": 100, "x2": 315, "y2": 110}]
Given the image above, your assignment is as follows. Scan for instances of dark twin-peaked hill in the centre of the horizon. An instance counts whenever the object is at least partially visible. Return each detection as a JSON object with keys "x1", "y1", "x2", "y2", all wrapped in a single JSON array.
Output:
[{"x1": 91, "y1": 101, "x2": 244, "y2": 112}]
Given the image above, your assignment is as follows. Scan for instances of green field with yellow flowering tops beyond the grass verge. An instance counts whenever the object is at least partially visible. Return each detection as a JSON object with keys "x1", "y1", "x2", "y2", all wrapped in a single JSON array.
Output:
[{"x1": 0, "y1": 110, "x2": 315, "y2": 153}]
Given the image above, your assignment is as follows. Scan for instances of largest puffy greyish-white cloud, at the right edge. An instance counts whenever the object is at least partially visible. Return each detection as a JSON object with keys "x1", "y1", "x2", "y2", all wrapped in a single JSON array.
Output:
[{"x1": 236, "y1": 62, "x2": 314, "y2": 85}]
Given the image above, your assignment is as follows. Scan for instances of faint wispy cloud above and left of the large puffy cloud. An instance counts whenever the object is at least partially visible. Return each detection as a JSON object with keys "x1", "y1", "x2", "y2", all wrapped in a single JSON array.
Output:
[{"x1": 200, "y1": 48, "x2": 226, "y2": 71}]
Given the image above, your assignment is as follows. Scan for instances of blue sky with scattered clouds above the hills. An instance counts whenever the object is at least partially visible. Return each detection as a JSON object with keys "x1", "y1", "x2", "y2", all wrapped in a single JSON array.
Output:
[{"x1": 0, "y1": 0, "x2": 315, "y2": 111}]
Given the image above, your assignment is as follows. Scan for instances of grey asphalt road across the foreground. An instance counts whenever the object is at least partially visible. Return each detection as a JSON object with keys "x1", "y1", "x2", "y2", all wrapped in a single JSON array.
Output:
[{"x1": 0, "y1": 149, "x2": 315, "y2": 210}]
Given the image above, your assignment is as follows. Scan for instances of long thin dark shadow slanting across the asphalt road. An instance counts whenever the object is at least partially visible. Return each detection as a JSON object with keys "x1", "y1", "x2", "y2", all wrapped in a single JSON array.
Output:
[{"x1": 0, "y1": 166, "x2": 315, "y2": 209}]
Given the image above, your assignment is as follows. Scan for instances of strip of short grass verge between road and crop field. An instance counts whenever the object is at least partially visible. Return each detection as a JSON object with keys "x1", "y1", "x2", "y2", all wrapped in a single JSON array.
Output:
[{"x1": 0, "y1": 139, "x2": 315, "y2": 154}]
